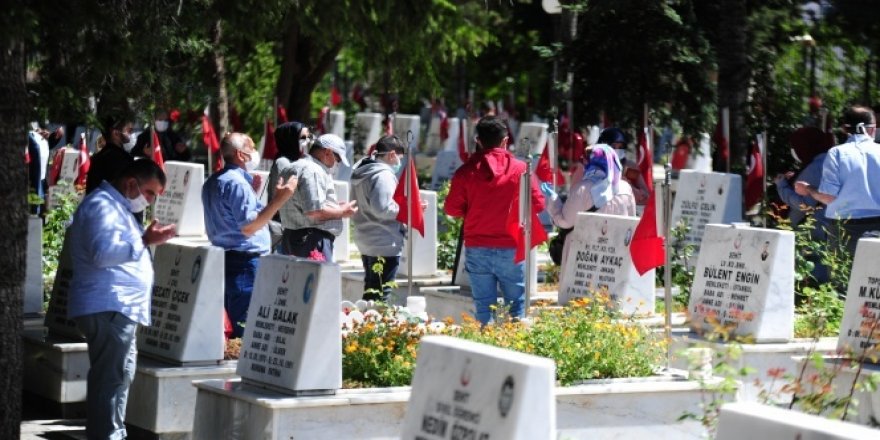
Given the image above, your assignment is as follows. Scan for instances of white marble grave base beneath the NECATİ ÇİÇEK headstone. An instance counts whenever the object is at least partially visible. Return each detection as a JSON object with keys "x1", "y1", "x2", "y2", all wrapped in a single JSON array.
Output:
[{"x1": 125, "y1": 356, "x2": 236, "y2": 440}]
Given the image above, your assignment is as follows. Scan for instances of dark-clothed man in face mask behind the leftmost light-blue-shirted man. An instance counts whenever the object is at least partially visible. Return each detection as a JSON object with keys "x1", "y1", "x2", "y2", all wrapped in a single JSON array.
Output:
[{"x1": 86, "y1": 112, "x2": 134, "y2": 194}]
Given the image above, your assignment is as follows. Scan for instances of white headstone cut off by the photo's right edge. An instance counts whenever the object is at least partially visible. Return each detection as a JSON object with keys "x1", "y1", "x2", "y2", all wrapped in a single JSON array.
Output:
[{"x1": 837, "y1": 238, "x2": 880, "y2": 362}]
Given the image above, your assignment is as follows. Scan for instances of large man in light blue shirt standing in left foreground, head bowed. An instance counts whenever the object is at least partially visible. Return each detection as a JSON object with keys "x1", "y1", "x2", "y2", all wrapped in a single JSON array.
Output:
[{"x1": 67, "y1": 159, "x2": 175, "y2": 440}]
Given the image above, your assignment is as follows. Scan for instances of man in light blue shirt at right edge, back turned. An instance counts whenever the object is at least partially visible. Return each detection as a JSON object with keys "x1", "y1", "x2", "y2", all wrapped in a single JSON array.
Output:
[{"x1": 795, "y1": 106, "x2": 880, "y2": 254}]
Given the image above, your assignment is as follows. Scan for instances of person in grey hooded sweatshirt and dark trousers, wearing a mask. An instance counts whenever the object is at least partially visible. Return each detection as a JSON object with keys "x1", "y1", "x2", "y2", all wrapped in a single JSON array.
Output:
[{"x1": 351, "y1": 136, "x2": 406, "y2": 301}]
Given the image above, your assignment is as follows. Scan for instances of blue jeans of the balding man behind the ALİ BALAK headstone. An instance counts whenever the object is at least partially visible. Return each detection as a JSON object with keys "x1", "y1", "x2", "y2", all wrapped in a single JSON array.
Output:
[{"x1": 223, "y1": 251, "x2": 260, "y2": 338}]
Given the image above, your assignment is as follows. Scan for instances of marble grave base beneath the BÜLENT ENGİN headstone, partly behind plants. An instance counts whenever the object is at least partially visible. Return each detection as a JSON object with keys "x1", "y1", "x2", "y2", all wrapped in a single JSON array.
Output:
[{"x1": 672, "y1": 332, "x2": 837, "y2": 404}]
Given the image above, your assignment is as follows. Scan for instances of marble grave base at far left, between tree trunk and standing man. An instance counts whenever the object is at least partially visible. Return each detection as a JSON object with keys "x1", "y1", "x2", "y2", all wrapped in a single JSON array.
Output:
[{"x1": 22, "y1": 331, "x2": 89, "y2": 404}]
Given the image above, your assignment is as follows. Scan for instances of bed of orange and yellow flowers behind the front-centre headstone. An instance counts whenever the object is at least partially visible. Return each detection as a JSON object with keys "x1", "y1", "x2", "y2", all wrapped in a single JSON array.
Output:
[{"x1": 342, "y1": 294, "x2": 665, "y2": 387}]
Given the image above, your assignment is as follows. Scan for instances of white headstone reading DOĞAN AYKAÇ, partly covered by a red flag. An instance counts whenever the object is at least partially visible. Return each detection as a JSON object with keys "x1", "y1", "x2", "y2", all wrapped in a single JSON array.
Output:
[{"x1": 559, "y1": 212, "x2": 655, "y2": 314}]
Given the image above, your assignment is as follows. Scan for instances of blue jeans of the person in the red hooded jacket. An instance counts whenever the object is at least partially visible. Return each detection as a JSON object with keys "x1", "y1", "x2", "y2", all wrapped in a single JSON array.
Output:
[{"x1": 465, "y1": 247, "x2": 526, "y2": 324}]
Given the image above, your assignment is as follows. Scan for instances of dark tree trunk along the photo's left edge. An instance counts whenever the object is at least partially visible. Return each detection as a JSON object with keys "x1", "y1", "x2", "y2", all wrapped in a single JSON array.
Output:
[{"x1": 0, "y1": 39, "x2": 28, "y2": 439}]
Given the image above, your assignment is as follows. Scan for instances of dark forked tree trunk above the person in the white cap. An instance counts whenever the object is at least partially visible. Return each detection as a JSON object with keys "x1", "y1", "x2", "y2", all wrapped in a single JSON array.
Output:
[{"x1": 275, "y1": 16, "x2": 342, "y2": 123}]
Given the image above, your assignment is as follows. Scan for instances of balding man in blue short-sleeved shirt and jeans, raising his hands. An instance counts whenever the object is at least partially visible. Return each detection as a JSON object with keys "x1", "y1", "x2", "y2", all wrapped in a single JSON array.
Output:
[{"x1": 202, "y1": 133, "x2": 297, "y2": 338}]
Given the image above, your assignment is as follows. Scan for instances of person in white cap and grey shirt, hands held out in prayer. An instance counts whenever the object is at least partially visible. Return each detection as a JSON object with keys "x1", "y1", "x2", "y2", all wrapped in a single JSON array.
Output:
[{"x1": 280, "y1": 134, "x2": 357, "y2": 261}]
